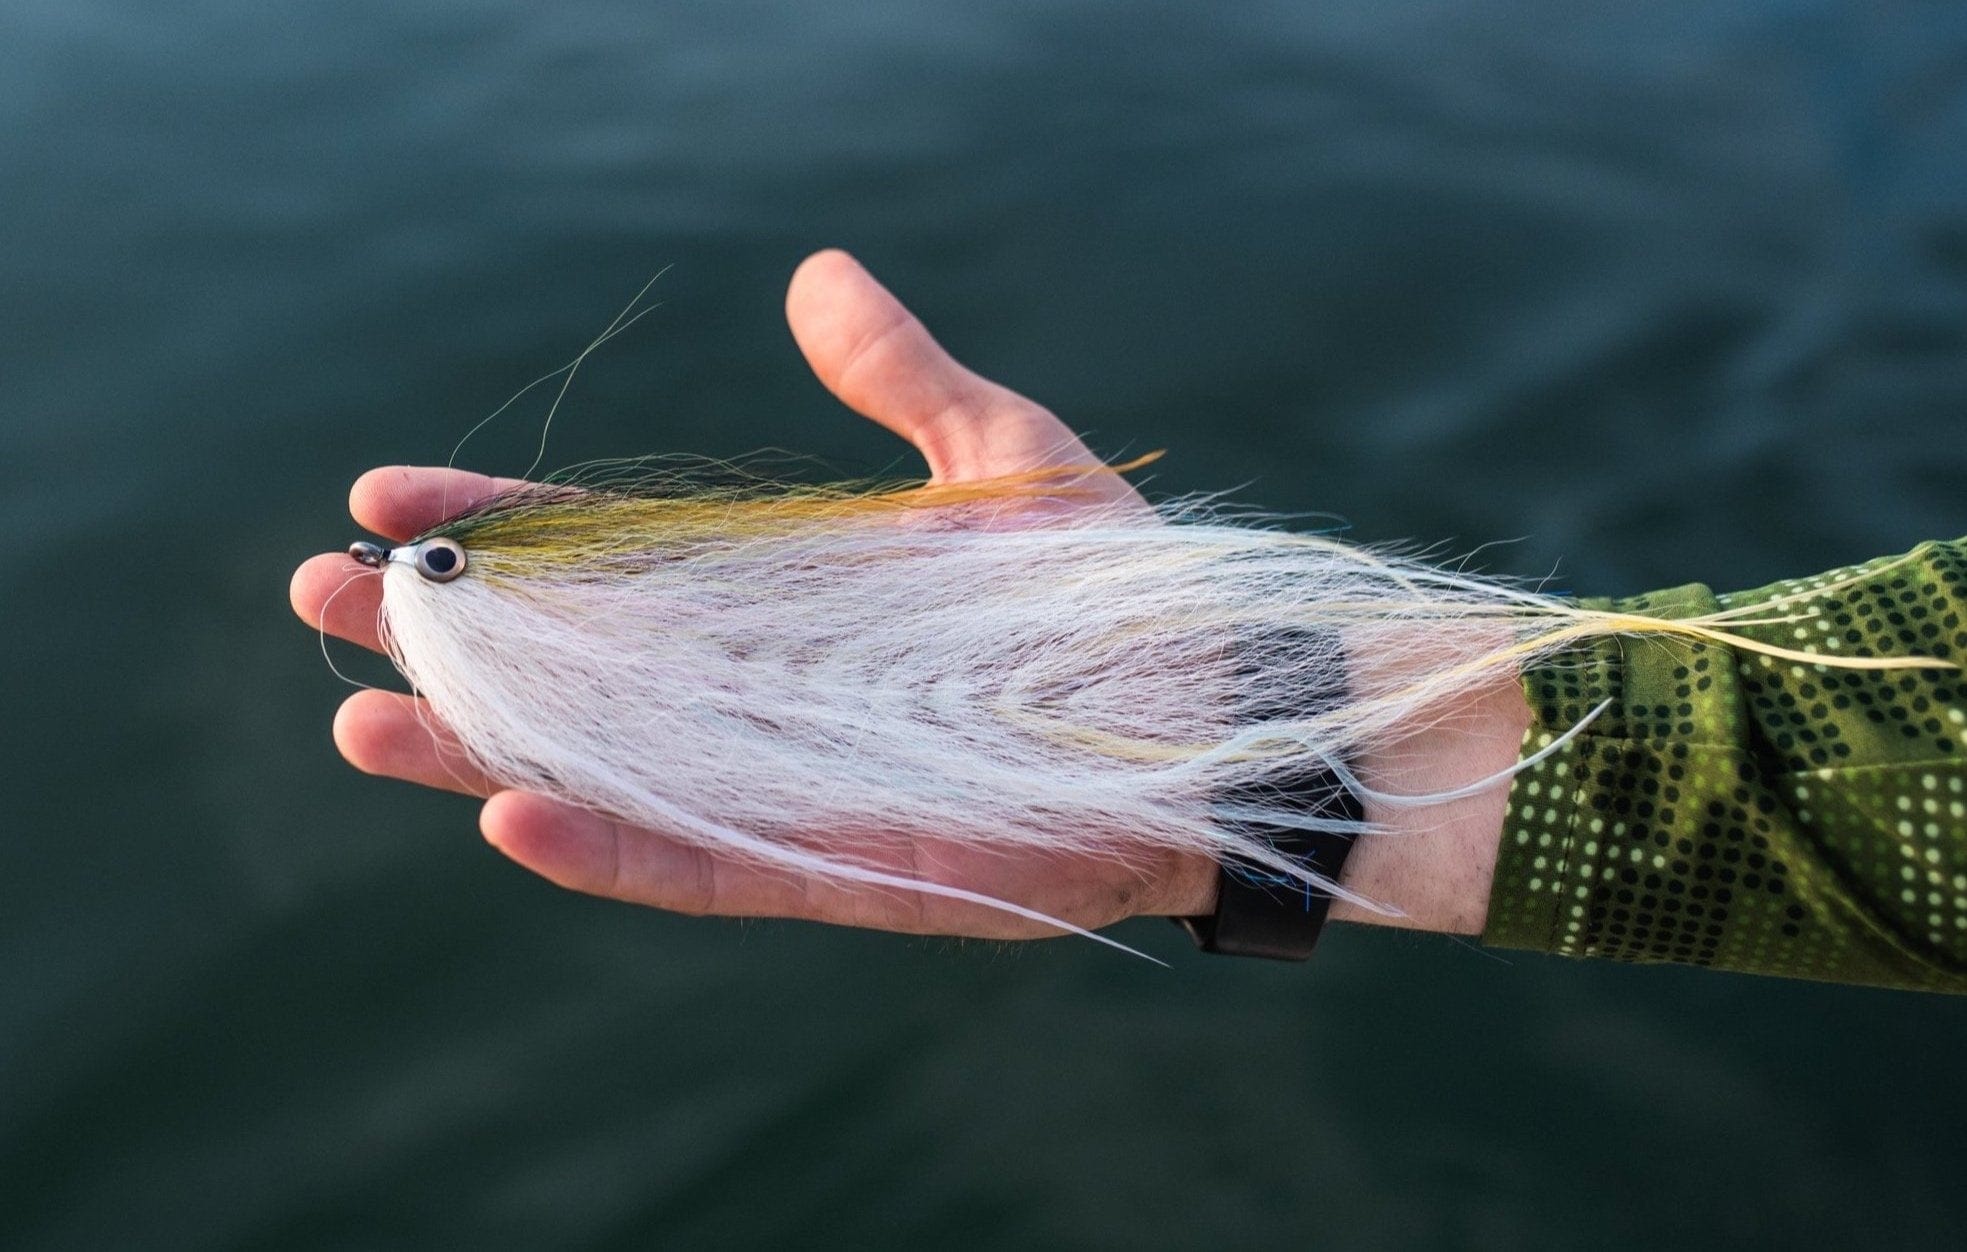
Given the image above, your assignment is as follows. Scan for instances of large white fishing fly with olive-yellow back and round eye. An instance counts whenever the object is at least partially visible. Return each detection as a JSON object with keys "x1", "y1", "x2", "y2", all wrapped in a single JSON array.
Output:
[{"x1": 350, "y1": 462, "x2": 1934, "y2": 945}]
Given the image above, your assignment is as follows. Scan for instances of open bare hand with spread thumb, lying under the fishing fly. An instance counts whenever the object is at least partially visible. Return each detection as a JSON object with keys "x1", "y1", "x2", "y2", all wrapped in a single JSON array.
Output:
[{"x1": 291, "y1": 252, "x2": 1216, "y2": 938}]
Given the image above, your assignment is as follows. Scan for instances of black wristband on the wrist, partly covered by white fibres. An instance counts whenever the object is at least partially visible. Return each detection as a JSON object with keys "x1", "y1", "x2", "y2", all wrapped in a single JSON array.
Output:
[{"x1": 1176, "y1": 631, "x2": 1365, "y2": 961}]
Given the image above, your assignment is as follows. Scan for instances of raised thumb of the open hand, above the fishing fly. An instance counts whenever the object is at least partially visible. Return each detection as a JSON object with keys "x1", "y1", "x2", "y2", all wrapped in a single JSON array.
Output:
[{"x1": 785, "y1": 250, "x2": 1092, "y2": 482}]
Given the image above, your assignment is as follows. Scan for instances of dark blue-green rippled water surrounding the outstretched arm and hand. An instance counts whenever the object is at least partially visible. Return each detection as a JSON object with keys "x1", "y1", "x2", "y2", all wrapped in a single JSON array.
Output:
[{"x1": 0, "y1": 0, "x2": 1967, "y2": 1248}]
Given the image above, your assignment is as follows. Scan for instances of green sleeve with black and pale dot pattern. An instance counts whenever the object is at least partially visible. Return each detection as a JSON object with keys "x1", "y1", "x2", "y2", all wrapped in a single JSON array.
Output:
[{"x1": 1483, "y1": 541, "x2": 1967, "y2": 993}]
